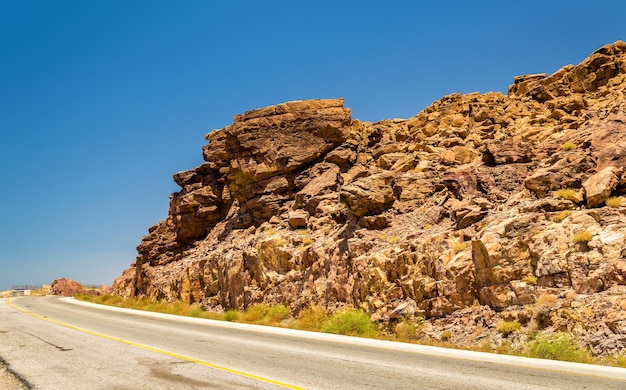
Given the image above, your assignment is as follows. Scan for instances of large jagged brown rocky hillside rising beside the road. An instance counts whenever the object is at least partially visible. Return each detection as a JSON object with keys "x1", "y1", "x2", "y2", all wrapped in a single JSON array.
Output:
[{"x1": 114, "y1": 41, "x2": 626, "y2": 354}]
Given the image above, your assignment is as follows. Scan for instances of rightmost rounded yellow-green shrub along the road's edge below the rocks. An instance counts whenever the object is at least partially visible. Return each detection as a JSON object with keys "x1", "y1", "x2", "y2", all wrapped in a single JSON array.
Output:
[{"x1": 524, "y1": 332, "x2": 592, "y2": 363}]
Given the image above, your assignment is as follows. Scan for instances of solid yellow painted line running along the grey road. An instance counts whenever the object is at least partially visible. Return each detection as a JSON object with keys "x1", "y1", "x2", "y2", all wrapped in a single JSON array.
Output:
[{"x1": 7, "y1": 299, "x2": 304, "y2": 390}]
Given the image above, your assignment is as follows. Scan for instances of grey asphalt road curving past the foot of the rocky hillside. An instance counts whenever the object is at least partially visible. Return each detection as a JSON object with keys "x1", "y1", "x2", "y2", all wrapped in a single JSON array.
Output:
[{"x1": 0, "y1": 297, "x2": 626, "y2": 390}]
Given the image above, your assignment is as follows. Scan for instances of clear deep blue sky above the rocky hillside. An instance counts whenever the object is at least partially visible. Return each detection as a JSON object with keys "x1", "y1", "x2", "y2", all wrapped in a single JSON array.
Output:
[{"x1": 0, "y1": 0, "x2": 626, "y2": 290}]
